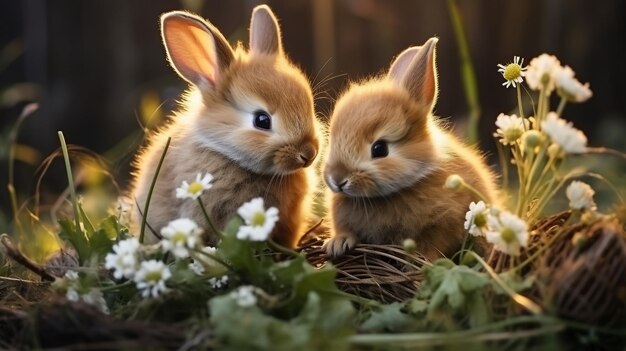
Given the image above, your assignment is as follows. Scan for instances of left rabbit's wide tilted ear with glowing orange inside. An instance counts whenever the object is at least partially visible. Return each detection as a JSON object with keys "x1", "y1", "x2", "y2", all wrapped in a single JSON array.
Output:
[{"x1": 161, "y1": 11, "x2": 234, "y2": 86}]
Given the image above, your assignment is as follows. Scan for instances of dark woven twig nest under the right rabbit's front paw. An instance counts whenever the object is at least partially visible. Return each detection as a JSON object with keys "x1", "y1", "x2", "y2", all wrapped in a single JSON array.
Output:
[{"x1": 300, "y1": 235, "x2": 426, "y2": 303}]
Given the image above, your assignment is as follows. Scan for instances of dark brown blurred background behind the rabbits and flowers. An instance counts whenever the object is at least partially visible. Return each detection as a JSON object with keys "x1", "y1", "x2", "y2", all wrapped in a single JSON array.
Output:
[{"x1": 0, "y1": 0, "x2": 626, "y2": 230}]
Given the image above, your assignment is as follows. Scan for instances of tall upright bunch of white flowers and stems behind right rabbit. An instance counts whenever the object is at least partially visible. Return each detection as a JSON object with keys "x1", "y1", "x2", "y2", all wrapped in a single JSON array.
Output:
[{"x1": 494, "y1": 54, "x2": 592, "y2": 222}]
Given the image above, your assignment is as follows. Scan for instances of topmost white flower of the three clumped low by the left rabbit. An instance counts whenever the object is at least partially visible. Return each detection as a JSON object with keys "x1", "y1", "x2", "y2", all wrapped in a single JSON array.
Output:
[{"x1": 161, "y1": 218, "x2": 202, "y2": 258}]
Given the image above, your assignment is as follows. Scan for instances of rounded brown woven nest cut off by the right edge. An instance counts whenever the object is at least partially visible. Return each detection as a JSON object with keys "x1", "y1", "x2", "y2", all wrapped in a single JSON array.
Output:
[{"x1": 536, "y1": 214, "x2": 626, "y2": 324}]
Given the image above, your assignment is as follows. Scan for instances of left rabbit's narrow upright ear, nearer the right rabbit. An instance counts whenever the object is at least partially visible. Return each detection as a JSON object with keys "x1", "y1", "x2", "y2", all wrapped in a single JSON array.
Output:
[{"x1": 250, "y1": 5, "x2": 283, "y2": 54}]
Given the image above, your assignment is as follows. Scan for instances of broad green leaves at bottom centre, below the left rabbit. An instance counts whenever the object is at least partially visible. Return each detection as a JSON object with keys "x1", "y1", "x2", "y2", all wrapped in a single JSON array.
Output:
[{"x1": 209, "y1": 219, "x2": 355, "y2": 350}]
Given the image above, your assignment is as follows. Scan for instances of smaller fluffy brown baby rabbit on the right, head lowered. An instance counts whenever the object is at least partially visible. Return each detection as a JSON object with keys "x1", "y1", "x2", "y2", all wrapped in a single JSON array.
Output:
[{"x1": 324, "y1": 38, "x2": 495, "y2": 260}]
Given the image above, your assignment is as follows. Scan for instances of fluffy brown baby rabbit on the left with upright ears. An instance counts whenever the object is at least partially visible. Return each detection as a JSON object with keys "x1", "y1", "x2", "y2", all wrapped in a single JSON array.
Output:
[{"x1": 132, "y1": 5, "x2": 319, "y2": 247}]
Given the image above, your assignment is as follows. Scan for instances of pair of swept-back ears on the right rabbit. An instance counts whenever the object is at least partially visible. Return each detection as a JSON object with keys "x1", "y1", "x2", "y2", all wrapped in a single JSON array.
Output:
[{"x1": 388, "y1": 38, "x2": 439, "y2": 107}]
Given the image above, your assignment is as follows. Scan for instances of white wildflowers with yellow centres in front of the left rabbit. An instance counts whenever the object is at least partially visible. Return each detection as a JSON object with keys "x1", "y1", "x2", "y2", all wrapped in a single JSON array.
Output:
[{"x1": 57, "y1": 173, "x2": 278, "y2": 311}]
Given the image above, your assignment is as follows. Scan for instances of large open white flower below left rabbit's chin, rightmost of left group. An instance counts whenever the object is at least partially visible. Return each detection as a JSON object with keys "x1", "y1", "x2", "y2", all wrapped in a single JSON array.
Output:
[{"x1": 237, "y1": 197, "x2": 278, "y2": 241}]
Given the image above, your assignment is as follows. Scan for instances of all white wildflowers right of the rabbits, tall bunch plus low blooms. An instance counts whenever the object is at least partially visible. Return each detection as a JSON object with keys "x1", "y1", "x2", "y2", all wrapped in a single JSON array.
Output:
[{"x1": 445, "y1": 54, "x2": 596, "y2": 256}]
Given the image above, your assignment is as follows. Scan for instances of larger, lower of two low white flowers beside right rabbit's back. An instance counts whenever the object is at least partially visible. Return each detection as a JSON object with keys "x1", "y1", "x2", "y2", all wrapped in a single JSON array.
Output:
[{"x1": 486, "y1": 211, "x2": 528, "y2": 256}]
